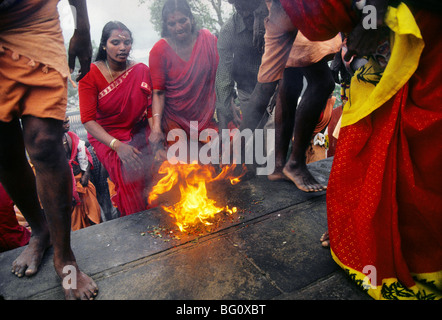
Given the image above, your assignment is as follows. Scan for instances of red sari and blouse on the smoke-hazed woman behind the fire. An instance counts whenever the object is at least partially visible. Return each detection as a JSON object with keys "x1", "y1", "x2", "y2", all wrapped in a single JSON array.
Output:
[{"x1": 149, "y1": 29, "x2": 219, "y2": 133}]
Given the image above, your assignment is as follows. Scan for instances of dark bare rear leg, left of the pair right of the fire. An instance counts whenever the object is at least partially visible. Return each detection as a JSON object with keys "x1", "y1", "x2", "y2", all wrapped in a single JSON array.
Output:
[{"x1": 268, "y1": 68, "x2": 303, "y2": 181}]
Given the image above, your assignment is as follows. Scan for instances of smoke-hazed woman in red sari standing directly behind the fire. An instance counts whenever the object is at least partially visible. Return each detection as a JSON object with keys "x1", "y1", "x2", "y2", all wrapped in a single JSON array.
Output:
[{"x1": 149, "y1": 0, "x2": 219, "y2": 154}]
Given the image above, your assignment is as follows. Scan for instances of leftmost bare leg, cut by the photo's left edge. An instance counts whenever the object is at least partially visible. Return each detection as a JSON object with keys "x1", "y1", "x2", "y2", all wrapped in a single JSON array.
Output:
[{"x1": 0, "y1": 120, "x2": 50, "y2": 277}]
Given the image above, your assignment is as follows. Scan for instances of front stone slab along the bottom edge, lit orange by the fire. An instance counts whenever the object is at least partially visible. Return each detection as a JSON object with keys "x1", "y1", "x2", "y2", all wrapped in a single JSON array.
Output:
[{"x1": 33, "y1": 237, "x2": 281, "y2": 300}]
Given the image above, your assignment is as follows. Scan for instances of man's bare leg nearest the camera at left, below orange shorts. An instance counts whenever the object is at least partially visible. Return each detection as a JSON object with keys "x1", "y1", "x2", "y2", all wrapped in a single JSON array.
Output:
[{"x1": 22, "y1": 116, "x2": 98, "y2": 299}]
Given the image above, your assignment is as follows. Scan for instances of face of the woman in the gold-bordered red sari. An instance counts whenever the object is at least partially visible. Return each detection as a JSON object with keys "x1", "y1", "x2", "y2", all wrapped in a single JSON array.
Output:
[{"x1": 106, "y1": 30, "x2": 132, "y2": 63}]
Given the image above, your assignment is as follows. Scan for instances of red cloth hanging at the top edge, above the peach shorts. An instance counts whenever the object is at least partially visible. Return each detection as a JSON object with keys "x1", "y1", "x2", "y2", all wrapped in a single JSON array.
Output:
[{"x1": 280, "y1": 0, "x2": 357, "y2": 41}]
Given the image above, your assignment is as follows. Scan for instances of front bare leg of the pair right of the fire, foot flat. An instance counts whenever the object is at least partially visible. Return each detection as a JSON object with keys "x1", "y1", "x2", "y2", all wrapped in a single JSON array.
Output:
[{"x1": 283, "y1": 60, "x2": 335, "y2": 192}]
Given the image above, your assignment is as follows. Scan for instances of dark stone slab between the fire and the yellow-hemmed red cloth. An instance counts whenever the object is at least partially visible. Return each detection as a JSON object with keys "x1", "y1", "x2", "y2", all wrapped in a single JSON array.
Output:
[{"x1": 229, "y1": 196, "x2": 338, "y2": 292}]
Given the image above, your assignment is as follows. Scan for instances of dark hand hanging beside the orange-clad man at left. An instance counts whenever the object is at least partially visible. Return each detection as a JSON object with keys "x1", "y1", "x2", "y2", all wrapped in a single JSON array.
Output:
[{"x1": 68, "y1": 29, "x2": 92, "y2": 82}]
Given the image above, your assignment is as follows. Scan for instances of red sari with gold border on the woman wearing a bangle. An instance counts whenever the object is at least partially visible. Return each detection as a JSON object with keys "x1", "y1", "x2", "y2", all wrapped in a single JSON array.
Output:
[{"x1": 79, "y1": 63, "x2": 152, "y2": 216}]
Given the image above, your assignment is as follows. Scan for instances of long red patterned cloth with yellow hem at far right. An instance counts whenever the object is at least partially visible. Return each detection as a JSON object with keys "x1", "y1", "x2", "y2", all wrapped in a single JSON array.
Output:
[{"x1": 327, "y1": 12, "x2": 442, "y2": 287}]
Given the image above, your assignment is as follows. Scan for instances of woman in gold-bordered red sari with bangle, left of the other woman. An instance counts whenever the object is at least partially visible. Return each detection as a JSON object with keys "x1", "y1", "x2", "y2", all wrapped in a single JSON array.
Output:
[{"x1": 79, "y1": 22, "x2": 152, "y2": 216}]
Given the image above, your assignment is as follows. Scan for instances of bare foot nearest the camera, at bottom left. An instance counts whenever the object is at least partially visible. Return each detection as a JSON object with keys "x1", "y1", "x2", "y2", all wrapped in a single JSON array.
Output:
[{"x1": 54, "y1": 261, "x2": 98, "y2": 300}]
